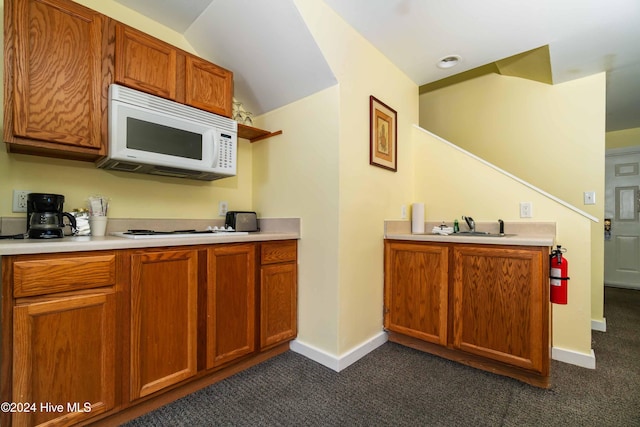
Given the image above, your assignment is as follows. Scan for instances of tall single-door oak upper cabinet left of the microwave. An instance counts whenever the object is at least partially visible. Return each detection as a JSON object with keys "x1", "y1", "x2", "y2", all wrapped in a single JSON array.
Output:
[{"x1": 4, "y1": 0, "x2": 106, "y2": 160}]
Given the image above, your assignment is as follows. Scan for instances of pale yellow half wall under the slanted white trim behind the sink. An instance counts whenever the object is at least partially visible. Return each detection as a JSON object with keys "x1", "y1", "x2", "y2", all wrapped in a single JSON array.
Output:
[{"x1": 414, "y1": 129, "x2": 592, "y2": 355}]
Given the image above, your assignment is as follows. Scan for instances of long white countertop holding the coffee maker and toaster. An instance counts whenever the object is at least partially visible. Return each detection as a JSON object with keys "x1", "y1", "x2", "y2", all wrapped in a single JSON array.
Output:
[{"x1": 0, "y1": 232, "x2": 300, "y2": 255}]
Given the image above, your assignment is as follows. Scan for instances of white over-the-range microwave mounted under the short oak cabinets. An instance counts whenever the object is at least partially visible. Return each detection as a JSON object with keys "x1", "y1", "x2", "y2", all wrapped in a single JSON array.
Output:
[{"x1": 96, "y1": 84, "x2": 238, "y2": 181}]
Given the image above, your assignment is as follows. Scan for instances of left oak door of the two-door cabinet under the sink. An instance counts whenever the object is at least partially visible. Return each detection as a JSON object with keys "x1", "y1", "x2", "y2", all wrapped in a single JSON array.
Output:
[{"x1": 384, "y1": 242, "x2": 449, "y2": 345}]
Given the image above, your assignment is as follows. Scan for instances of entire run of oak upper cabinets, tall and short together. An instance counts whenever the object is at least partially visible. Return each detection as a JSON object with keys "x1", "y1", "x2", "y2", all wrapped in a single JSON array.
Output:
[{"x1": 3, "y1": 0, "x2": 233, "y2": 161}]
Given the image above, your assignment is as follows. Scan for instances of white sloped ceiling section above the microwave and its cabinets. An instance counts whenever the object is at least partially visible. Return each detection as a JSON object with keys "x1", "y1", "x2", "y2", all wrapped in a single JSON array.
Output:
[{"x1": 184, "y1": 0, "x2": 337, "y2": 114}]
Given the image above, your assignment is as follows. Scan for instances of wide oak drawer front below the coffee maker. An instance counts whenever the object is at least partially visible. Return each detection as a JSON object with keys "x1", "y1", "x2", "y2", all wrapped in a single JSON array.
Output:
[{"x1": 13, "y1": 253, "x2": 116, "y2": 298}]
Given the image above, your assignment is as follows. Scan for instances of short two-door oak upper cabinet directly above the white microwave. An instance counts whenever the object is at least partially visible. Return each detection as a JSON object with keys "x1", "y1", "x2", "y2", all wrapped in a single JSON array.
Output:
[{"x1": 115, "y1": 23, "x2": 233, "y2": 117}]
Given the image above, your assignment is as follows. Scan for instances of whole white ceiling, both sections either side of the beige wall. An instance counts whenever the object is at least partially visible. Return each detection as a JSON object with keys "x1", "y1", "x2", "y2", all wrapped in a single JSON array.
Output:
[{"x1": 116, "y1": 0, "x2": 640, "y2": 131}]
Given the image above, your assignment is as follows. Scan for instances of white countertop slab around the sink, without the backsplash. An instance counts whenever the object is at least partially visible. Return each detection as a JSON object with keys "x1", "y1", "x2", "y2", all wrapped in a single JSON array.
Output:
[{"x1": 384, "y1": 233, "x2": 555, "y2": 246}]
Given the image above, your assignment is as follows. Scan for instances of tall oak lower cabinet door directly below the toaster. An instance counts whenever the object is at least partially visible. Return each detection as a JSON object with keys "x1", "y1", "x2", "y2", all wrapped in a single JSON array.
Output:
[{"x1": 207, "y1": 244, "x2": 256, "y2": 368}]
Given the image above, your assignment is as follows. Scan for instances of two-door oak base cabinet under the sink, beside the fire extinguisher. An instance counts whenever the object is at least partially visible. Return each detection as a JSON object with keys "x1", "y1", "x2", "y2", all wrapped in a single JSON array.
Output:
[{"x1": 384, "y1": 241, "x2": 550, "y2": 387}]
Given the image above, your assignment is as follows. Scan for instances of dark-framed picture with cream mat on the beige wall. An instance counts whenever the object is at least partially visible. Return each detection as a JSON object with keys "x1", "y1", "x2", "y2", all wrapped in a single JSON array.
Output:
[{"x1": 369, "y1": 95, "x2": 398, "y2": 172}]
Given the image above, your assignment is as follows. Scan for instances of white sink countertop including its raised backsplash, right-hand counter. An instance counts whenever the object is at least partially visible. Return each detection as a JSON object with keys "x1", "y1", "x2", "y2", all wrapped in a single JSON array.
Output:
[{"x1": 384, "y1": 221, "x2": 555, "y2": 246}]
